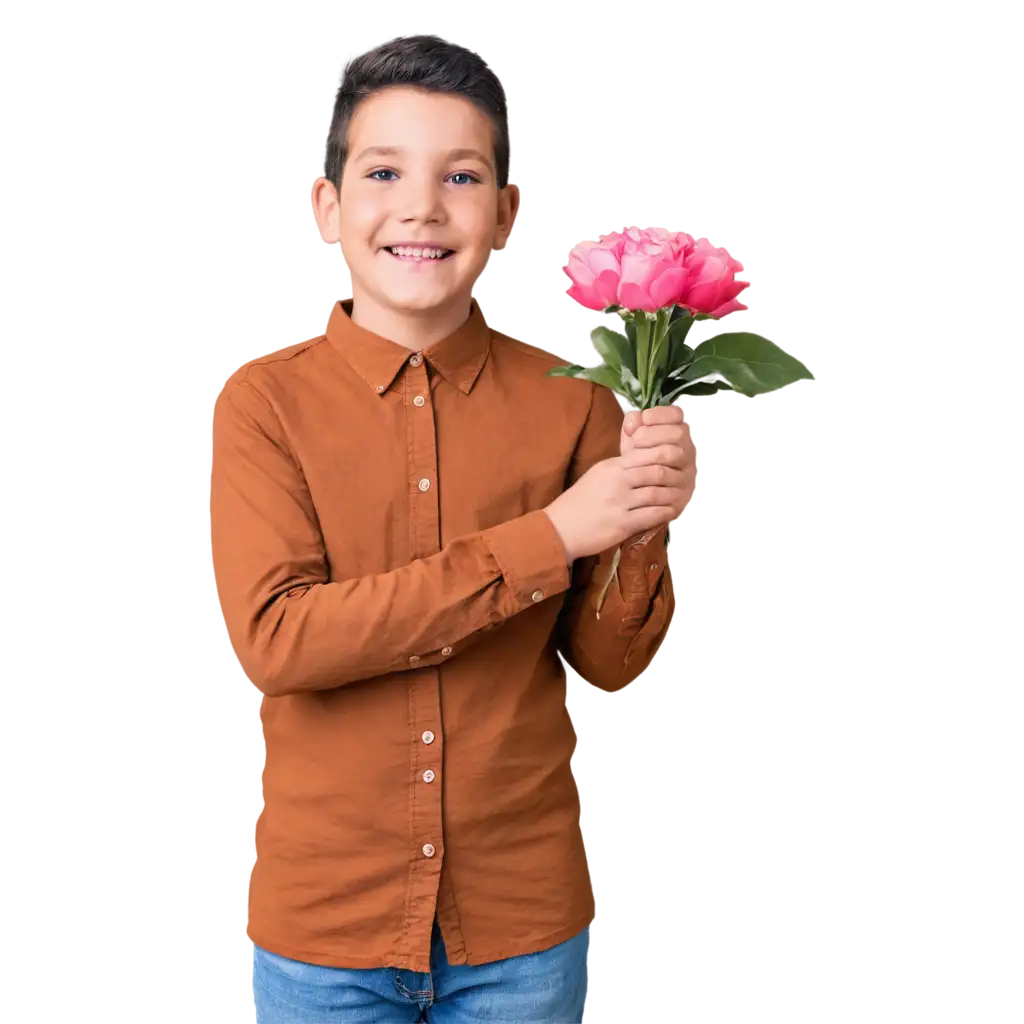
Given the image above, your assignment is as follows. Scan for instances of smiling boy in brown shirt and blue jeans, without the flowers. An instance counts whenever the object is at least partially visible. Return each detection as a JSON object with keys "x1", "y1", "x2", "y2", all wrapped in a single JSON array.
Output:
[{"x1": 203, "y1": 34, "x2": 688, "y2": 1024}]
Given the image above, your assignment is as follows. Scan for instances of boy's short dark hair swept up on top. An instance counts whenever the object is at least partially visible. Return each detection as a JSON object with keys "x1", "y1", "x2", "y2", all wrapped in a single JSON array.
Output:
[{"x1": 319, "y1": 32, "x2": 512, "y2": 188}]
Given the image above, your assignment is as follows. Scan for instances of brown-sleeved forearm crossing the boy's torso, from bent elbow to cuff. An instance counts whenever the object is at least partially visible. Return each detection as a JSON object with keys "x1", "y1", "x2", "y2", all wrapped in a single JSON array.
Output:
[{"x1": 218, "y1": 516, "x2": 568, "y2": 696}]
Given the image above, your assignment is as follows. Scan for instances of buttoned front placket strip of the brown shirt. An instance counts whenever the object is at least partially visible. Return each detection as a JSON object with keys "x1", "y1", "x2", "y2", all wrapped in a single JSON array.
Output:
[{"x1": 401, "y1": 353, "x2": 444, "y2": 958}]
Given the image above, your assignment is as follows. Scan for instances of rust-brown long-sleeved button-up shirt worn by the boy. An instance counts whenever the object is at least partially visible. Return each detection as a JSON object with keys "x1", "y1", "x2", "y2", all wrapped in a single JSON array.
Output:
[{"x1": 209, "y1": 304, "x2": 670, "y2": 971}]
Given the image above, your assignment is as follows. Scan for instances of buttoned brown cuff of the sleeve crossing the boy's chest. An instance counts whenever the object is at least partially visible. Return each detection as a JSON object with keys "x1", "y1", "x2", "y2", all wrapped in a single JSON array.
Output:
[{"x1": 483, "y1": 509, "x2": 570, "y2": 610}]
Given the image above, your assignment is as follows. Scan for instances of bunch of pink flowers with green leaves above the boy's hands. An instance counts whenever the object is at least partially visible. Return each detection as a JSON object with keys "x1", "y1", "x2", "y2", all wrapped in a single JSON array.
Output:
[{"x1": 548, "y1": 224, "x2": 806, "y2": 410}]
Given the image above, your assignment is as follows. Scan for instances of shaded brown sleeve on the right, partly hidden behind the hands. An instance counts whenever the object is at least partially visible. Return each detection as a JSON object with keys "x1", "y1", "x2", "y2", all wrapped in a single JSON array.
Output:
[{"x1": 559, "y1": 386, "x2": 672, "y2": 686}]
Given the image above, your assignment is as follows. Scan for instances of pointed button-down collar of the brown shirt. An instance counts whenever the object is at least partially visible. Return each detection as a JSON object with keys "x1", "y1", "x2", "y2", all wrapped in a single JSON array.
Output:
[{"x1": 326, "y1": 301, "x2": 490, "y2": 394}]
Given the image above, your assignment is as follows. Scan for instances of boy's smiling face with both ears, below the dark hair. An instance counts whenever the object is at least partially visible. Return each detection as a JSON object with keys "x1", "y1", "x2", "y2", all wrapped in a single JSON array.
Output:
[{"x1": 313, "y1": 87, "x2": 516, "y2": 322}]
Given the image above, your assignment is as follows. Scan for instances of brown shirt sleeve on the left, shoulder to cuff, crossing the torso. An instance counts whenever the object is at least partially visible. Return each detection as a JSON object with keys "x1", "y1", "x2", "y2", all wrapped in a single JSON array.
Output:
[{"x1": 208, "y1": 381, "x2": 569, "y2": 695}]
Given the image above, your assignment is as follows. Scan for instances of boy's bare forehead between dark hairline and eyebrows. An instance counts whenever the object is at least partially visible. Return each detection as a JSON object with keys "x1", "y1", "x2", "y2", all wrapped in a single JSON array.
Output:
[{"x1": 348, "y1": 86, "x2": 494, "y2": 159}]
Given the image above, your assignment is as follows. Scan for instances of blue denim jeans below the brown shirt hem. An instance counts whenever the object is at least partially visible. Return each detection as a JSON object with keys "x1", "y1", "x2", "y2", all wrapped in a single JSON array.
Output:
[{"x1": 249, "y1": 922, "x2": 590, "y2": 1024}]
